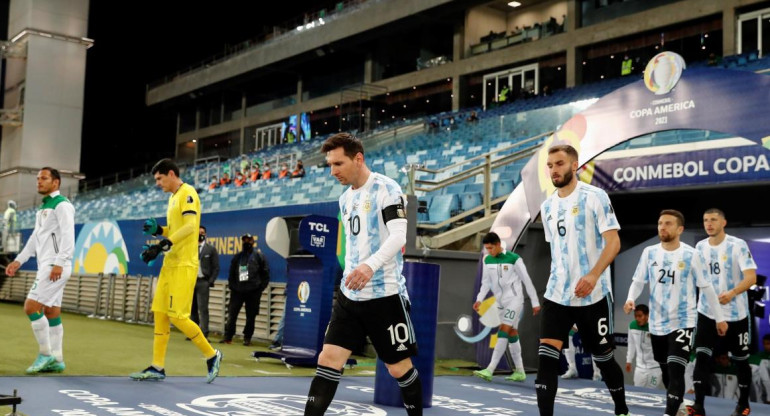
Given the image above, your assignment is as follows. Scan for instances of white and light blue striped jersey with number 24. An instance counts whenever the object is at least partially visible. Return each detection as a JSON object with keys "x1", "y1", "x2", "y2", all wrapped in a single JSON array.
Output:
[{"x1": 633, "y1": 243, "x2": 711, "y2": 335}]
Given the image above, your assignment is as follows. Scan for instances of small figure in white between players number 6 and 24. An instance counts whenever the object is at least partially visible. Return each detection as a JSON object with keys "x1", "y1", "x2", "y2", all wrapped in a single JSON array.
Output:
[{"x1": 626, "y1": 305, "x2": 663, "y2": 389}]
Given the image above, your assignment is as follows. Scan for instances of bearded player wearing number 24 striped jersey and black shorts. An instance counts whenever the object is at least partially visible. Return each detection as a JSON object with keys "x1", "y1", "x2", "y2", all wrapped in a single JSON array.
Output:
[{"x1": 623, "y1": 209, "x2": 727, "y2": 416}]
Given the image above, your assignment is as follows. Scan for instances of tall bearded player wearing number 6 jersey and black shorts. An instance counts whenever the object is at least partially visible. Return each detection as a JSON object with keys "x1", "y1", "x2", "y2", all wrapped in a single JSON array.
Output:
[{"x1": 535, "y1": 145, "x2": 628, "y2": 416}]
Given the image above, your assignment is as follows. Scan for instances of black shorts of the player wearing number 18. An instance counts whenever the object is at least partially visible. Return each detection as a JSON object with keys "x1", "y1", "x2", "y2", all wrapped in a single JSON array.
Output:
[{"x1": 695, "y1": 313, "x2": 751, "y2": 358}]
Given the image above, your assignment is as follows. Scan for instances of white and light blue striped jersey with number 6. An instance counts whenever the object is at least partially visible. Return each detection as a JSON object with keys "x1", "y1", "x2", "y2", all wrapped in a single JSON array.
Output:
[{"x1": 540, "y1": 182, "x2": 620, "y2": 306}]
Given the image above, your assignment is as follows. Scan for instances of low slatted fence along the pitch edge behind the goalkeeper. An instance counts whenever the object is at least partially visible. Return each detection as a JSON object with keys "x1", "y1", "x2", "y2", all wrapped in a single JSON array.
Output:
[{"x1": 0, "y1": 271, "x2": 286, "y2": 341}]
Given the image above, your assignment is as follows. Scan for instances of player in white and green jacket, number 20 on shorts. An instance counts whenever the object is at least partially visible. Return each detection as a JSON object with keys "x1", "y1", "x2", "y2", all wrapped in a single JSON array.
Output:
[{"x1": 473, "y1": 233, "x2": 540, "y2": 381}]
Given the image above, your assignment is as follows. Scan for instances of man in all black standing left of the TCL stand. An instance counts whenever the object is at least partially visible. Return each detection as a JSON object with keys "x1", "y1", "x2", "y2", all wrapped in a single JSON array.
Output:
[{"x1": 219, "y1": 233, "x2": 270, "y2": 346}]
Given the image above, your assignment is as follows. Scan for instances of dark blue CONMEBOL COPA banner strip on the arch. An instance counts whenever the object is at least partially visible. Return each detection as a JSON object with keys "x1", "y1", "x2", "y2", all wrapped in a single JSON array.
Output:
[{"x1": 591, "y1": 141, "x2": 770, "y2": 191}]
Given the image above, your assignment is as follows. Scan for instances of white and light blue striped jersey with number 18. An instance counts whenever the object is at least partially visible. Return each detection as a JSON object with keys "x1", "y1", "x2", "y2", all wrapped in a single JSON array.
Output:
[{"x1": 695, "y1": 235, "x2": 757, "y2": 322}]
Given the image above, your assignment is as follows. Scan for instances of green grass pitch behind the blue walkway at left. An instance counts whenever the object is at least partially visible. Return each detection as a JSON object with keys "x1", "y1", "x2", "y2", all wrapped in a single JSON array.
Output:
[{"x1": 0, "y1": 302, "x2": 475, "y2": 378}]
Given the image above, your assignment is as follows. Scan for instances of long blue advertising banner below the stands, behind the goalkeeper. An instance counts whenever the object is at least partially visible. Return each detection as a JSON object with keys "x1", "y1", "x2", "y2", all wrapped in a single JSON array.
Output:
[{"x1": 17, "y1": 201, "x2": 339, "y2": 283}]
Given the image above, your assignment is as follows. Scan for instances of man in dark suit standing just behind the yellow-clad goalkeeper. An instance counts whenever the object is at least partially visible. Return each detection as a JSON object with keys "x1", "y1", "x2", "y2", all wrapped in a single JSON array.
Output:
[{"x1": 187, "y1": 225, "x2": 219, "y2": 340}]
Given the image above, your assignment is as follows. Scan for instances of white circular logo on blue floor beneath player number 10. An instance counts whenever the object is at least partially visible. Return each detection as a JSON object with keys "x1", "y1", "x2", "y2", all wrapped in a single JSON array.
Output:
[{"x1": 177, "y1": 393, "x2": 388, "y2": 416}]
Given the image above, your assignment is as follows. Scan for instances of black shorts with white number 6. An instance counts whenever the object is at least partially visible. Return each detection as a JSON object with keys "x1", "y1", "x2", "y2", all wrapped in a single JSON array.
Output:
[{"x1": 540, "y1": 296, "x2": 615, "y2": 354}]
